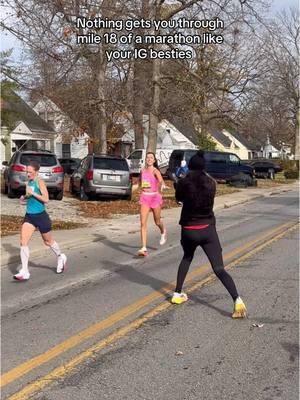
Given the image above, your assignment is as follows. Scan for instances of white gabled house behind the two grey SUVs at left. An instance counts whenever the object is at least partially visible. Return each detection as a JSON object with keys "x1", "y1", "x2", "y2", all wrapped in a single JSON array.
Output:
[{"x1": 33, "y1": 98, "x2": 89, "y2": 158}]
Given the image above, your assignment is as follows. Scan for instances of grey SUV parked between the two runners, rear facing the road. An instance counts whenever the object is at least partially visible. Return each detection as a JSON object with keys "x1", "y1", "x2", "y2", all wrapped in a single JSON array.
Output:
[{"x1": 70, "y1": 154, "x2": 132, "y2": 200}]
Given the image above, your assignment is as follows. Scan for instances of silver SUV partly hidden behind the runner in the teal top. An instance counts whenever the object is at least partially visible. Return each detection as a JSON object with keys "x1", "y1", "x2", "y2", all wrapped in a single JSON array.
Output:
[{"x1": 2, "y1": 150, "x2": 64, "y2": 200}]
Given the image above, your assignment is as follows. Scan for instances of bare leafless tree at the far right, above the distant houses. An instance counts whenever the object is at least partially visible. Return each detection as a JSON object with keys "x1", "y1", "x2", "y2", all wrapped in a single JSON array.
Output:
[{"x1": 241, "y1": 8, "x2": 299, "y2": 159}]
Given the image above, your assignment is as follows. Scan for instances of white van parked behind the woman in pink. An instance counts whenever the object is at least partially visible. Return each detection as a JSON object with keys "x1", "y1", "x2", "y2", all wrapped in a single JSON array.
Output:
[{"x1": 127, "y1": 148, "x2": 174, "y2": 175}]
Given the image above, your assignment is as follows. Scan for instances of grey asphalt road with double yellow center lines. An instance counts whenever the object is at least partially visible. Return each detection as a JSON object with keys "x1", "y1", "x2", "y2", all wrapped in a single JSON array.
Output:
[{"x1": 2, "y1": 191, "x2": 299, "y2": 400}]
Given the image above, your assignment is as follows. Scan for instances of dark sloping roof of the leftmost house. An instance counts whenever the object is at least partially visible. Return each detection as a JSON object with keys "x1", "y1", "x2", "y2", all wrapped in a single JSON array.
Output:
[{"x1": 1, "y1": 89, "x2": 55, "y2": 134}]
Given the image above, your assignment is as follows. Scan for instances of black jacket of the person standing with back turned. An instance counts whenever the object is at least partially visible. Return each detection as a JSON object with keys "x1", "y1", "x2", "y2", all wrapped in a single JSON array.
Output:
[{"x1": 176, "y1": 171, "x2": 216, "y2": 226}]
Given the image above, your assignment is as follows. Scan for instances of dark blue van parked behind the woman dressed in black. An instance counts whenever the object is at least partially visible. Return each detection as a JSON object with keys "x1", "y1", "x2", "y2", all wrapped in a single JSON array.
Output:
[{"x1": 168, "y1": 150, "x2": 254, "y2": 185}]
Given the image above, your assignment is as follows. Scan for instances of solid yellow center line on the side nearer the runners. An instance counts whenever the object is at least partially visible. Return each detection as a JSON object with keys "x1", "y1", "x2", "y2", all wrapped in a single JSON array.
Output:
[{"x1": 1, "y1": 220, "x2": 298, "y2": 399}]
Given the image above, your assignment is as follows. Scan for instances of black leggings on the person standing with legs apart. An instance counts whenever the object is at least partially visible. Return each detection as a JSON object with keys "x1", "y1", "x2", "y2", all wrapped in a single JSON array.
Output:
[{"x1": 175, "y1": 225, "x2": 238, "y2": 301}]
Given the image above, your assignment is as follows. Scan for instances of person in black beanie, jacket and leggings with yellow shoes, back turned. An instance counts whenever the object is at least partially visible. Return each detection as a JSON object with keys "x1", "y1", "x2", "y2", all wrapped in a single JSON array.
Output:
[{"x1": 171, "y1": 151, "x2": 247, "y2": 318}]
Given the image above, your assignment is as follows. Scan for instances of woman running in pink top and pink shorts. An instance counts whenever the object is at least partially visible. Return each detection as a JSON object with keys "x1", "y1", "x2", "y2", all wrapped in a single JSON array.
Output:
[{"x1": 138, "y1": 152, "x2": 167, "y2": 256}]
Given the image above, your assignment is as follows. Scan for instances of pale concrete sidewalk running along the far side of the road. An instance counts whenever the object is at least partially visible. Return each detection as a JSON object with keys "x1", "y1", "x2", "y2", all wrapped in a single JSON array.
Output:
[{"x1": 1, "y1": 182, "x2": 298, "y2": 267}]
